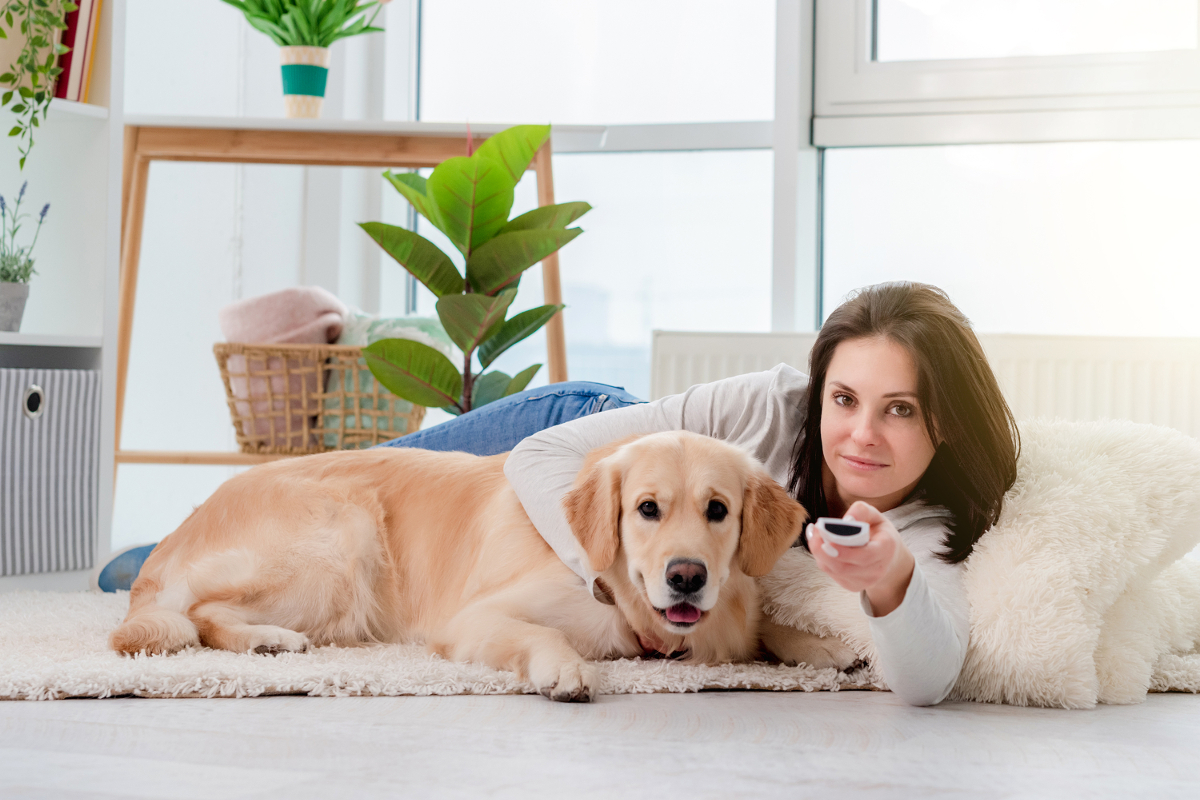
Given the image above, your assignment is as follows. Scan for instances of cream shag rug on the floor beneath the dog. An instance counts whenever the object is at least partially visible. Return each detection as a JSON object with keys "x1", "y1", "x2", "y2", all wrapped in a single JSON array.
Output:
[{"x1": 0, "y1": 591, "x2": 882, "y2": 700}]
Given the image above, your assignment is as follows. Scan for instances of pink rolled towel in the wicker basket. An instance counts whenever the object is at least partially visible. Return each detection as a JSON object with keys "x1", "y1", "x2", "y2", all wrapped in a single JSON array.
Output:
[{"x1": 220, "y1": 287, "x2": 350, "y2": 450}]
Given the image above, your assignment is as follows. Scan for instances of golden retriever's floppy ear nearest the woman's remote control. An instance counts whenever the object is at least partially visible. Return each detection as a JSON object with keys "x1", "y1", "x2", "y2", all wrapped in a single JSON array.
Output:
[{"x1": 738, "y1": 473, "x2": 809, "y2": 578}]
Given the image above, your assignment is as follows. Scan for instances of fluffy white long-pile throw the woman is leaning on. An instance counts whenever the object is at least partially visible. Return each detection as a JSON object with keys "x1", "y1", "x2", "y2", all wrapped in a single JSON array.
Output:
[{"x1": 762, "y1": 420, "x2": 1200, "y2": 708}]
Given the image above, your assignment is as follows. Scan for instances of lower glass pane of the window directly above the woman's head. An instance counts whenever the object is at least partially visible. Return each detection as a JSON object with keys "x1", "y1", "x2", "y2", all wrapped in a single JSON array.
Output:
[{"x1": 822, "y1": 140, "x2": 1200, "y2": 336}]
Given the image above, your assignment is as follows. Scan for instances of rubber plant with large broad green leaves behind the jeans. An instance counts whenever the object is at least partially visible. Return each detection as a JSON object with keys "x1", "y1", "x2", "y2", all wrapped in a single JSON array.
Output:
[{"x1": 360, "y1": 125, "x2": 592, "y2": 414}]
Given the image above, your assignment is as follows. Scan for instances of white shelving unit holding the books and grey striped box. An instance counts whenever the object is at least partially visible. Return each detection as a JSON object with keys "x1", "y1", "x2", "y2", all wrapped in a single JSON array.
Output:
[{"x1": 0, "y1": 0, "x2": 125, "y2": 591}]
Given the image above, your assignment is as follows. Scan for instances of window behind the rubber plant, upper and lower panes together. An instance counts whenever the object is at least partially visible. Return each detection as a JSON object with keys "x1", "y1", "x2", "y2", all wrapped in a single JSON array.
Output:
[{"x1": 417, "y1": 0, "x2": 775, "y2": 397}]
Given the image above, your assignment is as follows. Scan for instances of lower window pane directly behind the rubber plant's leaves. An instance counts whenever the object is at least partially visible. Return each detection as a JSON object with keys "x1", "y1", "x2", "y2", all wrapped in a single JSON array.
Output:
[{"x1": 384, "y1": 150, "x2": 772, "y2": 400}]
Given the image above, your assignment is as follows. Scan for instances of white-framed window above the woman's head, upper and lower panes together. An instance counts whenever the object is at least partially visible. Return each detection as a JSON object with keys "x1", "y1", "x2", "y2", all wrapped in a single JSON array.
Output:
[{"x1": 814, "y1": 0, "x2": 1200, "y2": 336}]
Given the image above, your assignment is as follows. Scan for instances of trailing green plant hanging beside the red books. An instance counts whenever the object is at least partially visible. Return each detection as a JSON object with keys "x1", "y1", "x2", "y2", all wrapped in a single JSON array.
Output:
[{"x1": 0, "y1": 0, "x2": 79, "y2": 169}]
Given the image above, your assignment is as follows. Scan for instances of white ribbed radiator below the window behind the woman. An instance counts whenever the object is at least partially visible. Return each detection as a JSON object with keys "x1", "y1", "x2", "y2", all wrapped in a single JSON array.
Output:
[{"x1": 650, "y1": 331, "x2": 1200, "y2": 437}]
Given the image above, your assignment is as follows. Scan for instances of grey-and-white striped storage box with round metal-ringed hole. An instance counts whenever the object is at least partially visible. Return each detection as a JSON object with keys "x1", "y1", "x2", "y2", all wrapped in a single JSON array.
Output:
[{"x1": 0, "y1": 369, "x2": 100, "y2": 576}]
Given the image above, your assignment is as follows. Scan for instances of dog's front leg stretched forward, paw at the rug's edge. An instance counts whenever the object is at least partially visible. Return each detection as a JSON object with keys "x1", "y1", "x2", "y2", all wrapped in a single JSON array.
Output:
[{"x1": 428, "y1": 603, "x2": 600, "y2": 703}]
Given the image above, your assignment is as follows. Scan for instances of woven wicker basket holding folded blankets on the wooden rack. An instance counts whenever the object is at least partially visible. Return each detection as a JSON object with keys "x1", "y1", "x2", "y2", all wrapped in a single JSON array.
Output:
[{"x1": 212, "y1": 343, "x2": 425, "y2": 456}]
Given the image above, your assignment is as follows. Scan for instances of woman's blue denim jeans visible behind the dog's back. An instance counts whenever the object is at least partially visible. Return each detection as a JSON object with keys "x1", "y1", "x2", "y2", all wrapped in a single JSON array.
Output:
[{"x1": 377, "y1": 380, "x2": 644, "y2": 456}]
